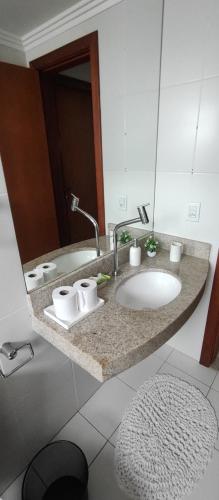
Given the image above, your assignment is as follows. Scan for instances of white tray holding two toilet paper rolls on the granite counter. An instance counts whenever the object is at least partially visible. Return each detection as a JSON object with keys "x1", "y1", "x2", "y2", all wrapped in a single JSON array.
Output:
[{"x1": 44, "y1": 279, "x2": 104, "y2": 330}]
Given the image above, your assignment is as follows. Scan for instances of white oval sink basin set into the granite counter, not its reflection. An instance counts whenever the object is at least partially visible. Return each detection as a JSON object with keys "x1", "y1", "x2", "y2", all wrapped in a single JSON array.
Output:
[{"x1": 116, "y1": 270, "x2": 182, "y2": 309}]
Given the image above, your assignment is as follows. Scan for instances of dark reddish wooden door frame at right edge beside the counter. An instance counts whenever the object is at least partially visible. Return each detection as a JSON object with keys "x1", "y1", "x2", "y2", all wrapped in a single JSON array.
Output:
[{"x1": 200, "y1": 253, "x2": 219, "y2": 366}]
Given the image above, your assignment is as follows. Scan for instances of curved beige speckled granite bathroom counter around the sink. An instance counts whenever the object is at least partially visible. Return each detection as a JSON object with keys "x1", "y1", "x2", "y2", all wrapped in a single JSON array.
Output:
[{"x1": 32, "y1": 250, "x2": 209, "y2": 382}]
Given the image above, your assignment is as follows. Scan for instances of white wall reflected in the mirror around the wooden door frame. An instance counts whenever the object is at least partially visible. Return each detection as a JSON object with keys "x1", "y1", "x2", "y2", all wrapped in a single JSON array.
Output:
[{"x1": 27, "y1": 0, "x2": 162, "y2": 230}]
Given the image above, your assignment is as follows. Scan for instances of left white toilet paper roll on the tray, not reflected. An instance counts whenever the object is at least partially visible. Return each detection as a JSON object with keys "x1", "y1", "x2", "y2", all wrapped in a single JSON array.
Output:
[{"x1": 52, "y1": 286, "x2": 78, "y2": 321}]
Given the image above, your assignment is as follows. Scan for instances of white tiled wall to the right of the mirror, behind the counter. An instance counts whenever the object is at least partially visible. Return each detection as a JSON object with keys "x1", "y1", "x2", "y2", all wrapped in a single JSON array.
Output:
[{"x1": 155, "y1": 0, "x2": 219, "y2": 359}]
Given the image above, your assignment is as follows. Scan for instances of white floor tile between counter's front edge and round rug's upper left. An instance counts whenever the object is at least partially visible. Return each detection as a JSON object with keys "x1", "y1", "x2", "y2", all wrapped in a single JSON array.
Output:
[{"x1": 118, "y1": 354, "x2": 163, "y2": 389}]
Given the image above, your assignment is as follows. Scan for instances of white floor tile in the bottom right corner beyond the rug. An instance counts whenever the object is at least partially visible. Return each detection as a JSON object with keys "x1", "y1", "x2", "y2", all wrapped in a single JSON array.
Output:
[{"x1": 182, "y1": 451, "x2": 219, "y2": 500}]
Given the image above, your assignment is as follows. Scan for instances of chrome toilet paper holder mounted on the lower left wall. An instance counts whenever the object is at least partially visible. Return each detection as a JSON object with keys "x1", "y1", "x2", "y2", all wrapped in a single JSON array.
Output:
[{"x1": 0, "y1": 342, "x2": 34, "y2": 378}]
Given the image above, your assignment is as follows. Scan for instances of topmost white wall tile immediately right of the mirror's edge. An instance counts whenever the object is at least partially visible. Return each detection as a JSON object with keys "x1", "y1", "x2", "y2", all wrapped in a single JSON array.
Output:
[{"x1": 162, "y1": 0, "x2": 209, "y2": 86}]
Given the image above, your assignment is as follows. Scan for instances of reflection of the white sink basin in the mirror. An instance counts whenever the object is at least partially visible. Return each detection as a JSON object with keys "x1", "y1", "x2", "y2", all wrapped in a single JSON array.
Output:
[{"x1": 52, "y1": 248, "x2": 103, "y2": 273}]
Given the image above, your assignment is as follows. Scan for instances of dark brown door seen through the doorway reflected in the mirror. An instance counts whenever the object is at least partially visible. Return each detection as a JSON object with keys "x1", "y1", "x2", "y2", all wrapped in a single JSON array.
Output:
[{"x1": 56, "y1": 76, "x2": 98, "y2": 243}]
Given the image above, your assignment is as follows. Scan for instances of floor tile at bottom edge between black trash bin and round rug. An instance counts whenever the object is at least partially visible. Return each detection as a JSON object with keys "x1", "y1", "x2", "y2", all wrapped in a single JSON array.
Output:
[{"x1": 88, "y1": 443, "x2": 130, "y2": 500}]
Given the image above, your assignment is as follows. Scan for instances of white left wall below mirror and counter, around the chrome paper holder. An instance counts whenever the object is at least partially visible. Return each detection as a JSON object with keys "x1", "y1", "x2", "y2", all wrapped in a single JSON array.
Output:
[{"x1": 0, "y1": 149, "x2": 100, "y2": 494}]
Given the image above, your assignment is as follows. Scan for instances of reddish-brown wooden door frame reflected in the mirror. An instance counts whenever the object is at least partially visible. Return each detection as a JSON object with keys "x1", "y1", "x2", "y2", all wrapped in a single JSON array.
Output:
[{"x1": 30, "y1": 31, "x2": 105, "y2": 235}]
